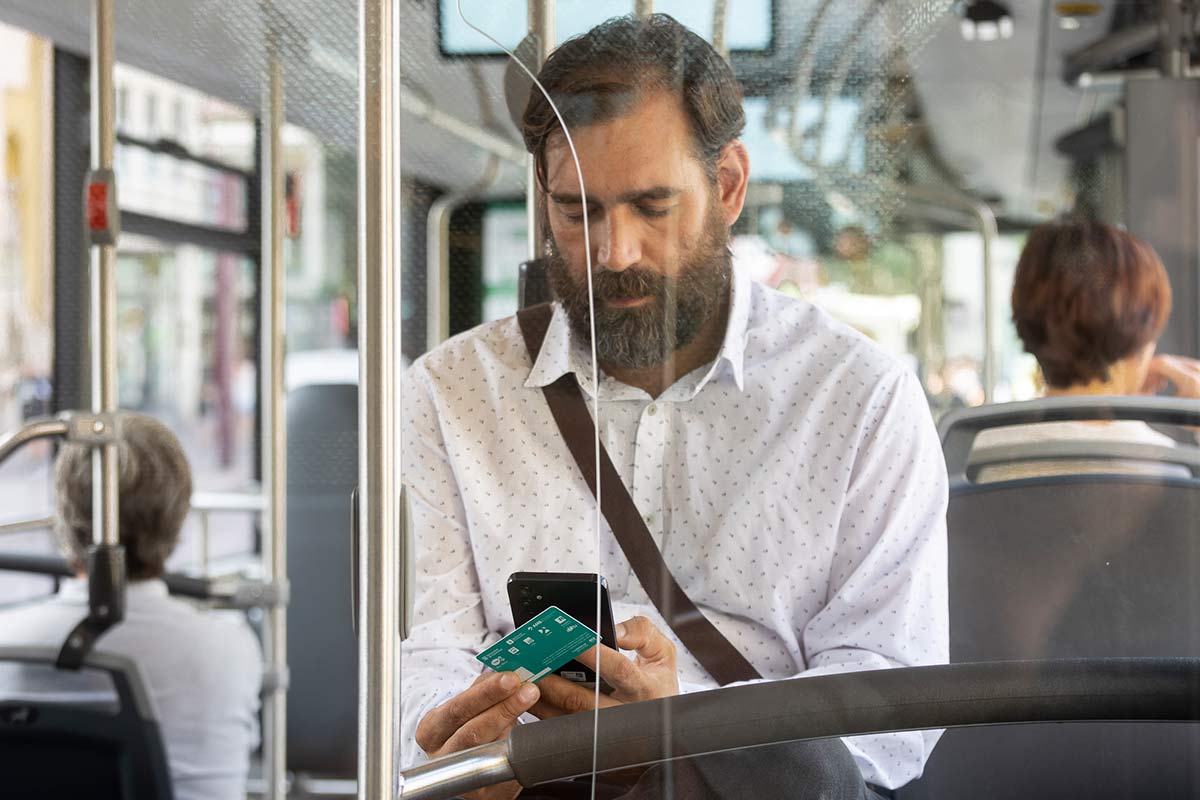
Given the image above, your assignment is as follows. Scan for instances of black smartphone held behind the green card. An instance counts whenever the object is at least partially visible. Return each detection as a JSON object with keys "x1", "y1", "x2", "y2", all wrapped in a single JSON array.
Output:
[{"x1": 509, "y1": 572, "x2": 617, "y2": 693}]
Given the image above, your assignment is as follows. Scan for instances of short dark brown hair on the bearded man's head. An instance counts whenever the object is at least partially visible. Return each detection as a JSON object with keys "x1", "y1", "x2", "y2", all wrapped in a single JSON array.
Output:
[{"x1": 522, "y1": 14, "x2": 745, "y2": 187}]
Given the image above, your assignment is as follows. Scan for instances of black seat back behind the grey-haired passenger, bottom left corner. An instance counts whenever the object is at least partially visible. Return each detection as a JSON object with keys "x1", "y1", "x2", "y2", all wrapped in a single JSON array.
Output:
[{"x1": 0, "y1": 648, "x2": 173, "y2": 800}]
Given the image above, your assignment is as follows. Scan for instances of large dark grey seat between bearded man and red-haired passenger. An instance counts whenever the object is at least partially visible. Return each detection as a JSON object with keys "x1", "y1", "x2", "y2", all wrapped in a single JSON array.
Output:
[{"x1": 896, "y1": 399, "x2": 1200, "y2": 800}]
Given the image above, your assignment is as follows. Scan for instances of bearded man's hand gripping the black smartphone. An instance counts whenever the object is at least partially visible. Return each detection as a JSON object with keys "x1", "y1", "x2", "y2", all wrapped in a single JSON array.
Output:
[{"x1": 533, "y1": 616, "x2": 679, "y2": 720}]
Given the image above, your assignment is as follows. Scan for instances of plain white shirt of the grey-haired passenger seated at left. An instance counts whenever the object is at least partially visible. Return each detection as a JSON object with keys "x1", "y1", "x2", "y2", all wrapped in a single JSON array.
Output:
[{"x1": 0, "y1": 579, "x2": 263, "y2": 800}]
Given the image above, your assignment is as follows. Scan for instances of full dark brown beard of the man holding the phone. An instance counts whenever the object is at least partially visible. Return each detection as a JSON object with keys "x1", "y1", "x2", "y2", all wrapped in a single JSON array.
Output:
[{"x1": 547, "y1": 204, "x2": 733, "y2": 369}]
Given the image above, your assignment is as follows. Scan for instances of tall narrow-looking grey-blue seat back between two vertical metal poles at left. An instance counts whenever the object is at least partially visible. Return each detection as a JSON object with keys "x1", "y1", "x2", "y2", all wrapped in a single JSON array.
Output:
[{"x1": 287, "y1": 384, "x2": 359, "y2": 777}]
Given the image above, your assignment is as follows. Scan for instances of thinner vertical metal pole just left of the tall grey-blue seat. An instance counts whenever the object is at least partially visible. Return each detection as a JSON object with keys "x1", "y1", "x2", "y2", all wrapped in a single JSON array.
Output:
[{"x1": 259, "y1": 32, "x2": 288, "y2": 800}]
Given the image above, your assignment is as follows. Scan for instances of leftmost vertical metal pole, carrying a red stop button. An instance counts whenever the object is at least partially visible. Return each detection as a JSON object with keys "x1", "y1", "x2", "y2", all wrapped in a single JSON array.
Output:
[{"x1": 91, "y1": 0, "x2": 120, "y2": 546}]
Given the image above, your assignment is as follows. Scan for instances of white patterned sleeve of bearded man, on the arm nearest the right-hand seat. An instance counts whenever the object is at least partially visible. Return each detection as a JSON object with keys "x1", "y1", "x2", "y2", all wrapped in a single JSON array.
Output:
[{"x1": 802, "y1": 369, "x2": 949, "y2": 788}]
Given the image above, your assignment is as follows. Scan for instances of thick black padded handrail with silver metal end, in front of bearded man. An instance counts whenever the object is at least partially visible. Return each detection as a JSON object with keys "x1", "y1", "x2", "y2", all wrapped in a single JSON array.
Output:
[{"x1": 400, "y1": 657, "x2": 1200, "y2": 800}]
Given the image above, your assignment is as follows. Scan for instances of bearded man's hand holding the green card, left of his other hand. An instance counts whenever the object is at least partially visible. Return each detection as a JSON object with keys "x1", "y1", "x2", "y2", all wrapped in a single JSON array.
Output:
[{"x1": 416, "y1": 672, "x2": 540, "y2": 800}]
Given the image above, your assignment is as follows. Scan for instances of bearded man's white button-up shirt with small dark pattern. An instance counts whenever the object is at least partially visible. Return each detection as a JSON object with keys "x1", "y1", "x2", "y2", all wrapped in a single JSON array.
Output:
[{"x1": 401, "y1": 263, "x2": 948, "y2": 788}]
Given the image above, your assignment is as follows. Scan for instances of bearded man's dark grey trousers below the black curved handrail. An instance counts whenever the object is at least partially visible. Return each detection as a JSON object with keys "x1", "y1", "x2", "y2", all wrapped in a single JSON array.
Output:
[{"x1": 521, "y1": 739, "x2": 880, "y2": 800}]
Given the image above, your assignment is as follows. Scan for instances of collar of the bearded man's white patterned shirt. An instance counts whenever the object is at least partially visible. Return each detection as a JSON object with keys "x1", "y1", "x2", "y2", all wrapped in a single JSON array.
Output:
[{"x1": 526, "y1": 267, "x2": 751, "y2": 399}]
